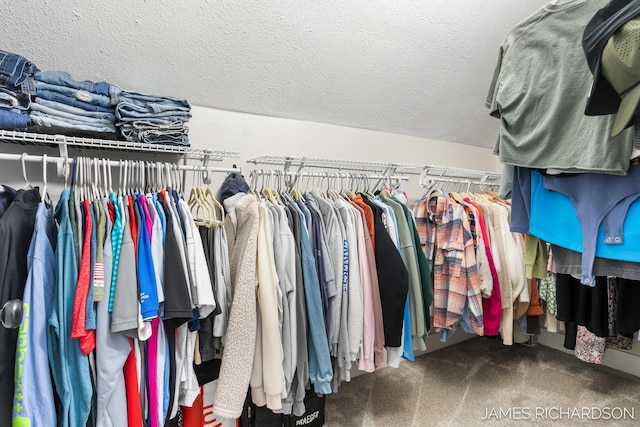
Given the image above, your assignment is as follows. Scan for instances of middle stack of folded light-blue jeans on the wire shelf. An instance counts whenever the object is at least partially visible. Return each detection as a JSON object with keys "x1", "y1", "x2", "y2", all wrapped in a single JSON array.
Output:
[{"x1": 30, "y1": 71, "x2": 116, "y2": 134}]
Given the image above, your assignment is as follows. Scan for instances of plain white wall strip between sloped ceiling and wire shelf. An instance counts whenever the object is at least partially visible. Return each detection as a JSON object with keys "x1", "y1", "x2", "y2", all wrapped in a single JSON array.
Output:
[{"x1": 189, "y1": 107, "x2": 500, "y2": 198}]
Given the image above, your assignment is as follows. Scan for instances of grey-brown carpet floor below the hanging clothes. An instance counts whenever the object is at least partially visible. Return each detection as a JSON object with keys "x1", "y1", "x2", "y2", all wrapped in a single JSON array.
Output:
[{"x1": 325, "y1": 336, "x2": 640, "y2": 427}]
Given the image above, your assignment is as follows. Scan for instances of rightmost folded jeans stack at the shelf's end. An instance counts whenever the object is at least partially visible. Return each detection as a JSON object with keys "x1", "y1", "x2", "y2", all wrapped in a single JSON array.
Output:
[{"x1": 111, "y1": 86, "x2": 191, "y2": 146}]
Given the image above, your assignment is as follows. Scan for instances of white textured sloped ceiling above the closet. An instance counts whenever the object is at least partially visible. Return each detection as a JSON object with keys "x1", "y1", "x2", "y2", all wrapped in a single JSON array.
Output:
[{"x1": 0, "y1": 0, "x2": 544, "y2": 147}]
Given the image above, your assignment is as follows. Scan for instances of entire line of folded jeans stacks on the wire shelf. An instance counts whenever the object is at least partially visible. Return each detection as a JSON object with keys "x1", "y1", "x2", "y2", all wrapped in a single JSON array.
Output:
[{"x1": 0, "y1": 51, "x2": 191, "y2": 146}]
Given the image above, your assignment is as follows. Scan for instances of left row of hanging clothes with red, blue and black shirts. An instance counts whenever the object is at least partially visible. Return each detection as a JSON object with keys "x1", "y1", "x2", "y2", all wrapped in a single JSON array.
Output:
[{"x1": 0, "y1": 155, "x2": 237, "y2": 427}]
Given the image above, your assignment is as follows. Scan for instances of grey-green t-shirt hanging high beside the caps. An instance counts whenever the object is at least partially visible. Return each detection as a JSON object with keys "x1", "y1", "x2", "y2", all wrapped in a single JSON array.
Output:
[{"x1": 486, "y1": 0, "x2": 633, "y2": 175}]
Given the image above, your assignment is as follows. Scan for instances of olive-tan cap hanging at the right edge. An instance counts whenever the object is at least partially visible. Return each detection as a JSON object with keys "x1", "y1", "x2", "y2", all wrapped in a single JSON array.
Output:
[{"x1": 602, "y1": 18, "x2": 640, "y2": 136}]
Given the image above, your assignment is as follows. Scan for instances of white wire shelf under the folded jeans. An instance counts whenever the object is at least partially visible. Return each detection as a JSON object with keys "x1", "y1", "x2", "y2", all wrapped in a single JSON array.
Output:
[{"x1": 0, "y1": 130, "x2": 240, "y2": 160}]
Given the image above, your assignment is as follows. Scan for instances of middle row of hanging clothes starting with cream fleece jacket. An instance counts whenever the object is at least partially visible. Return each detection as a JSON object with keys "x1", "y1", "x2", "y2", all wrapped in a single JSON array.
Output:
[{"x1": 214, "y1": 169, "x2": 432, "y2": 418}]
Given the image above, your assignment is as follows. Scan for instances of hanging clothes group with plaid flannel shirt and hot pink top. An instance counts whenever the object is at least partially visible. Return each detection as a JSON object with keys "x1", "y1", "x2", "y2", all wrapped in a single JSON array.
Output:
[{"x1": 413, "y1": 180, "x2": 542, "y2": 345}]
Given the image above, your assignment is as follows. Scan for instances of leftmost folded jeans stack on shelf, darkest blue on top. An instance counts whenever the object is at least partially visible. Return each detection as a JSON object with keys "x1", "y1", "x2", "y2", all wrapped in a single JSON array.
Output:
[{"x1": 0, "y1": 51, "x2": 40, "y2": 129}]
